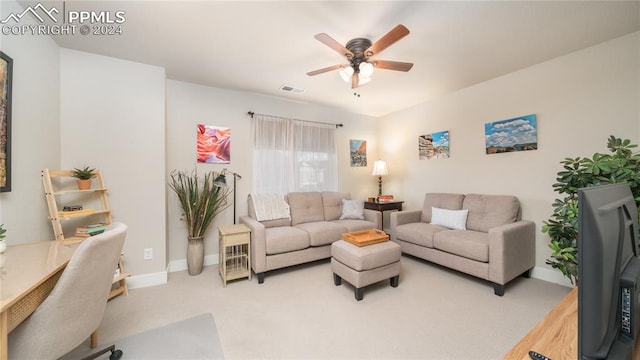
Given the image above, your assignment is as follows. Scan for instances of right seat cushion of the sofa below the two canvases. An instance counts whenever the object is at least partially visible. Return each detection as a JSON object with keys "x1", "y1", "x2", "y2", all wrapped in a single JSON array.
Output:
[{"x1": 433, "y1": 230, "x2": 489, "y2": 263}]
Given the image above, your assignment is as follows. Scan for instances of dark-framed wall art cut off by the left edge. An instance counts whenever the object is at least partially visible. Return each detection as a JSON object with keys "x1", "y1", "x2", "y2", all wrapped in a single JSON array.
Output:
[{"x1": 0, "y1": 51, "x2": 13, "y2": 192}]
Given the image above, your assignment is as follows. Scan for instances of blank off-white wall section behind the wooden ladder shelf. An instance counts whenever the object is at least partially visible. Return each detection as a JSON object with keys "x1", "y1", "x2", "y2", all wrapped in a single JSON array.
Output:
[{"x1": 60, "y1": 49, "x2": 167, "y2": 287}]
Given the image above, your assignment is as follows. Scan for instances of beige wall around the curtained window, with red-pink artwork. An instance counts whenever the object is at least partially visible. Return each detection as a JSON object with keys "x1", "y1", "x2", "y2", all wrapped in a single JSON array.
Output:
[{"x1": 167, "y1": 80, "x2": 378, "y2": 270}]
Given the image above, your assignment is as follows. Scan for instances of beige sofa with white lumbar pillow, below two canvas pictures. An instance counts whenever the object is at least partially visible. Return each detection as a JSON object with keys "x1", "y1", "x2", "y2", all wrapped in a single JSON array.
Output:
[{"x1": 390, "y1": 193, "x2": 535, "y2": 296}]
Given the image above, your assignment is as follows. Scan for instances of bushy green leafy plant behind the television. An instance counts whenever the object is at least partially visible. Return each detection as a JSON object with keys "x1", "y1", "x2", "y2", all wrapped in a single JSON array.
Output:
[{"x1": 542, "y1": 135, "x2": 640, "y2": 284}]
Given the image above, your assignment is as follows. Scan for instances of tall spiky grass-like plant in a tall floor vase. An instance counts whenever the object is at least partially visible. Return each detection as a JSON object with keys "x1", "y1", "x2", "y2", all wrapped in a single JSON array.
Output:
[{"x1": 169, "y1": 170, "x2": 231, "y2": 275}]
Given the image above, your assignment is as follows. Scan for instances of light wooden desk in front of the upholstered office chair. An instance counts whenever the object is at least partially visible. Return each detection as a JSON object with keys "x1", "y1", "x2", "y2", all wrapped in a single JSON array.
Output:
[{"x1": 0, "y1": 241, "x2": 77, "y2": 360}]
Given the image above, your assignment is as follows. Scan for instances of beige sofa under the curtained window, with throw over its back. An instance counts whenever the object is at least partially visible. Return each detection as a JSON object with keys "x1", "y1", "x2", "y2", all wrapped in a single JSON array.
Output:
[{"x1": 240, "y1": 192, "x2": 382, "y2": 284}]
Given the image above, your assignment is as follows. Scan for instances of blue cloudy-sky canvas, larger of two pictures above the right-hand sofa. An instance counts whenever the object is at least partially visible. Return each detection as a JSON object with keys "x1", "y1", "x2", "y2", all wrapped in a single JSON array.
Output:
[{"x1": 484, "y1": 114, "x2": 538, "y2": 151}]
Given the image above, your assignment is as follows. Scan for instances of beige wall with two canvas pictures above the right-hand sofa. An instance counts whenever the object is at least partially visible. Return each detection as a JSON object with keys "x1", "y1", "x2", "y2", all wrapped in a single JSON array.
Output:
[{"x1": 378, "y1": 33, "x2": 640, "y2": 282}]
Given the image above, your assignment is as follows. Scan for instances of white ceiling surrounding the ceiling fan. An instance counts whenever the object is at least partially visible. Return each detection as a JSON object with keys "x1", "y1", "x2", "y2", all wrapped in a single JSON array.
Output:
[{"x1": 20, "y1": 1, "x2": 640, "y2": 116}]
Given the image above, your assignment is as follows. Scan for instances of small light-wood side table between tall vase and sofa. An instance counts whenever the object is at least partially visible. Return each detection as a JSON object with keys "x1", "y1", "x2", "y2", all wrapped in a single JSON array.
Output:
[{"x1": 218, "y1": 224, "x2": 251, "y2": 287}]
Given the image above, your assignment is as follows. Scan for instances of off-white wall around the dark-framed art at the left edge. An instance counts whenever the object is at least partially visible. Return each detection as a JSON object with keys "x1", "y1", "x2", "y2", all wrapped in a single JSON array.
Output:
[{"x1": 0, "y1": 1, "x2": 60, "y2": 244}]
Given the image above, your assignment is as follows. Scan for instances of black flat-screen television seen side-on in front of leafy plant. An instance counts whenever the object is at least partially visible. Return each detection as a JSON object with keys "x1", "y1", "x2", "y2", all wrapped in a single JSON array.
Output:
[{"x1": 578, "y1": 184, "x2": 640, "y2": 360}]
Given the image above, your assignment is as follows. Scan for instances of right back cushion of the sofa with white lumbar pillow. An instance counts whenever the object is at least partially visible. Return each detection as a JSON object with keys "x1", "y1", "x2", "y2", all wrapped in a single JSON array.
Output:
[{"x1": 462, "y1": 194, "x2": 520, "y2": 232}]
